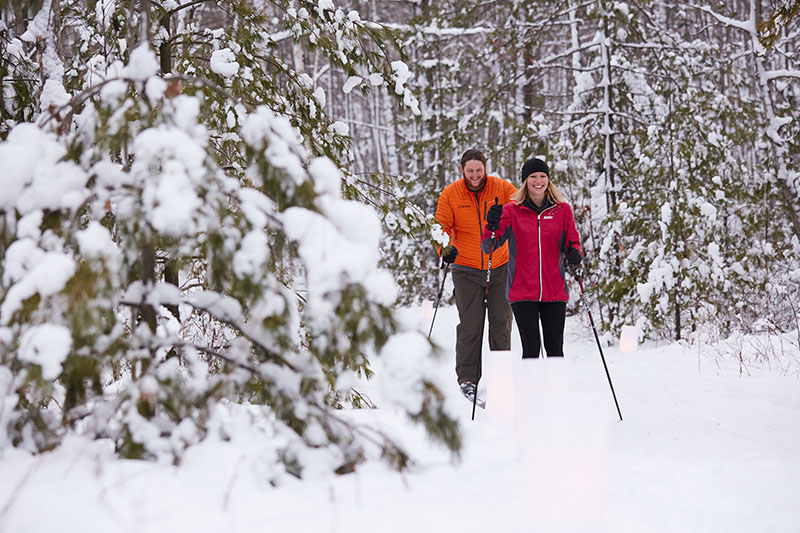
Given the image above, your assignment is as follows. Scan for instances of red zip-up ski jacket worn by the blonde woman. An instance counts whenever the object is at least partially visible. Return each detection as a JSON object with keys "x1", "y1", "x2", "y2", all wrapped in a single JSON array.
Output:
[{"x1": 481, "y1": 202, "x2": 581, "y2": 303}]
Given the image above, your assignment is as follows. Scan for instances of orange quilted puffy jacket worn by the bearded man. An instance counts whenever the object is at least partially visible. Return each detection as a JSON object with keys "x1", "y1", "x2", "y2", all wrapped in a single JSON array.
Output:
[{"x1": 436, "y1": 176, "x2": 517, "y2": 270}]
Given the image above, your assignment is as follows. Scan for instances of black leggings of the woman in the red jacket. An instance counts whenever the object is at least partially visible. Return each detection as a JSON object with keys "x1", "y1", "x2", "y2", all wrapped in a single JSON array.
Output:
[{"x1": 511, "y1": 302, "x2": 567, "y2": 358}]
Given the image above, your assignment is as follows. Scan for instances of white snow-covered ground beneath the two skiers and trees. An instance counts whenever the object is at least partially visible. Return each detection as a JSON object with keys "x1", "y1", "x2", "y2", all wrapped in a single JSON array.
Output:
[{"x1": 0, "y1": 308, "x2": 800, "y2": 533}]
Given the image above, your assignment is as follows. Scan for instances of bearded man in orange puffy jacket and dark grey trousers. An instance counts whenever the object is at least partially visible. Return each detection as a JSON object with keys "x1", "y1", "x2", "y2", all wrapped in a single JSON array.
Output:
[{"x1": 436, "y1": 149, "x2": 516, "y2": 400}]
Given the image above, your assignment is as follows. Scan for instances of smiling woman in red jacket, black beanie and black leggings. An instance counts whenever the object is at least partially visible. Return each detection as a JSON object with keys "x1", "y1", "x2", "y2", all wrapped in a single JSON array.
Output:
[{"x1": 481, "y1": 158, "x2": 581, "y2": 358}]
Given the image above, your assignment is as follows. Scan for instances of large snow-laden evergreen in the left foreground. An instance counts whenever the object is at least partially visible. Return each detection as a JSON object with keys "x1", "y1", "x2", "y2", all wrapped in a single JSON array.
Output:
[{"x1": 0, "y1": 2, "x2": 459, "y2": 476}]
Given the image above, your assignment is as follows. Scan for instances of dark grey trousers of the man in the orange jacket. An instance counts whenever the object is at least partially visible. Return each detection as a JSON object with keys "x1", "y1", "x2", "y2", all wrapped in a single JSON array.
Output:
[{"x1": 453, "y1": 265, "x2": 511, "y2": 383}]
